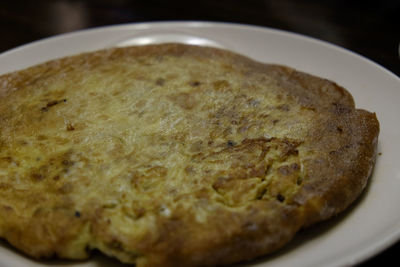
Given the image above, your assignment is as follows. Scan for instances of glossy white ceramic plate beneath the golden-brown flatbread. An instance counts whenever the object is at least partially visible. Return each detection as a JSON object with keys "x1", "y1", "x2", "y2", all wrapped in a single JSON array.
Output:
[{"x1": 0, "y1": 22, "x2": 400, "y2": 267}]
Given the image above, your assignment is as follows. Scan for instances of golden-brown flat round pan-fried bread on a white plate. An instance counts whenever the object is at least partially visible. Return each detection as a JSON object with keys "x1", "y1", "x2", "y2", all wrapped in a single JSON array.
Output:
[{"x1": 0, "y1": 44, "x2": 379, "y2": 267}]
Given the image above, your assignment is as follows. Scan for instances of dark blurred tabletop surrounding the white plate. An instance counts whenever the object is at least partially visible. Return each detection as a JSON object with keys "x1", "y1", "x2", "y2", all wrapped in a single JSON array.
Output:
[{"x1": 0, "y1": 0, "x2": 400, "y2": 267}]
